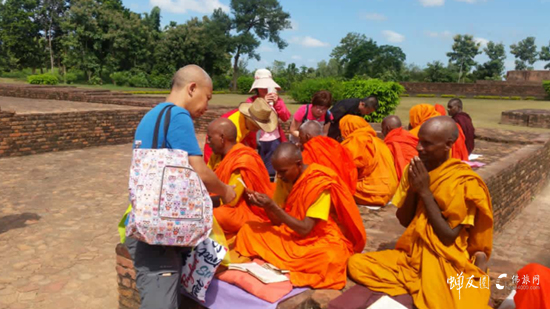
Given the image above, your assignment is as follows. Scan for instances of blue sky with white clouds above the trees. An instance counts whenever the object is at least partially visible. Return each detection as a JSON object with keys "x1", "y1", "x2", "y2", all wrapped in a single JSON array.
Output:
[{"x1": 123, "y1": 0, "x2": 550, "y2": 70}]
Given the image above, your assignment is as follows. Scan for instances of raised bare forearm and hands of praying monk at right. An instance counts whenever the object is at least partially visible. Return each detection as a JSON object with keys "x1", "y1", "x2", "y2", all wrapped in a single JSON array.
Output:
[{"x1": 409, "y1": 157, "x2": 463, "y2": 246}]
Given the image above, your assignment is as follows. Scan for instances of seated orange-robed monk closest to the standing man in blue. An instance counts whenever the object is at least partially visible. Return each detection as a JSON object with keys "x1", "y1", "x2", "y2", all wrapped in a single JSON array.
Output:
[{"x1": 207, "y1": 118, "x2": 272, "y2": 238}]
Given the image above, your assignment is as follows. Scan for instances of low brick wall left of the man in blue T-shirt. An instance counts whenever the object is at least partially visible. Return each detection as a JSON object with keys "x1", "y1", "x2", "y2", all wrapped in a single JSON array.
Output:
[{"x1": 0, "y1": 109, "x2": 147, "y2": 157}]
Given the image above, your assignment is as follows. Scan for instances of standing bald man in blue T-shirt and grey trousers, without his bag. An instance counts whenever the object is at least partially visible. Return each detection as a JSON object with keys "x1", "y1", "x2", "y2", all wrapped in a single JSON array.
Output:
[{"x1": 121, "y1": 65, "x2": 236, "y2": 309}]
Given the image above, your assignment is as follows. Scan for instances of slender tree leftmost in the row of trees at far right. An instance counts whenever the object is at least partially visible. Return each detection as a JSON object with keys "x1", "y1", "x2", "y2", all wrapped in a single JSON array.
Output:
[{"x1": 447, "y1": 34, "x2": 481, "y2": 82}]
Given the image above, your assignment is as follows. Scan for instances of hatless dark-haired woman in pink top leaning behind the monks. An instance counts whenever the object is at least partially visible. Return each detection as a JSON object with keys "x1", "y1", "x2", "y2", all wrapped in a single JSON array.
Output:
[{"x1": 290, "y1": 90, "x2": 334, "y2": 143}]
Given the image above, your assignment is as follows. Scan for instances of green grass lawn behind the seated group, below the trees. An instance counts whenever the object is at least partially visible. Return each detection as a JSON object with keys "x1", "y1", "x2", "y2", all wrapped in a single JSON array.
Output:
[{"x1": 210, "y1": 94, "x2": 550, "y2": 132}]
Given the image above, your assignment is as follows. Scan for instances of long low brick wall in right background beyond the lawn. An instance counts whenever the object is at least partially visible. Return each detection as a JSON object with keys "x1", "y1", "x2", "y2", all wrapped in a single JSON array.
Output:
[{"x1": 400, "y1": 82, "x2": 547, "y2": 99}]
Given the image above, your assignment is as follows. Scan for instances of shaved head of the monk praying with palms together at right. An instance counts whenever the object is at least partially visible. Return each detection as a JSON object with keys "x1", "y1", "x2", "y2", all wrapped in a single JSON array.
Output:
[{"x1": 417, "y1": 116, "x2": 459, "y2": 171}]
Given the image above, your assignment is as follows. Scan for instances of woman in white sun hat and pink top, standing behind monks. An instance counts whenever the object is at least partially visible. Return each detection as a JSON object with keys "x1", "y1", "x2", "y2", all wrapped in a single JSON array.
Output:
[{"x1": 246, "y1": 69, "x2": 290, "y2": 179}]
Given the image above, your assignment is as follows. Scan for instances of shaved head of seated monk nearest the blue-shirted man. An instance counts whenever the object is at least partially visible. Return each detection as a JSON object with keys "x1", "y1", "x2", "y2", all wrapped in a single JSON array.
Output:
[{"x1": 206, "y1": 118, "x2": 237, "y2": 157}]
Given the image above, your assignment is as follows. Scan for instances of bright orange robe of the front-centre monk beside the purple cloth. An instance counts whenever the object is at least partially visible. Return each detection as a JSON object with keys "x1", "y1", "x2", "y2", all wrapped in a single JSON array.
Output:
[{"x1": 235, "y1": 164, "x2": 366, "y2": 289}]
